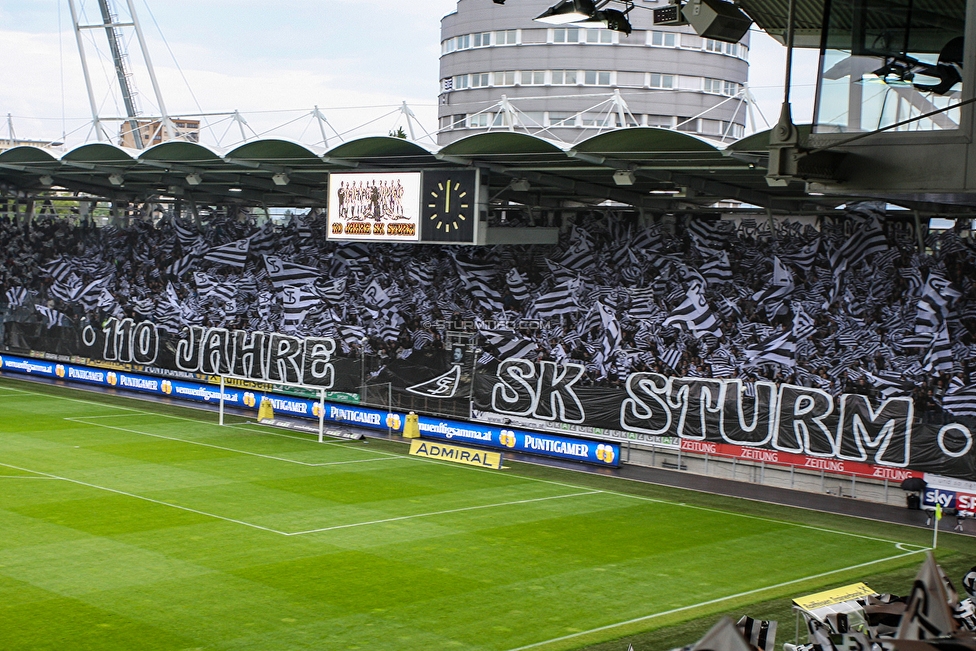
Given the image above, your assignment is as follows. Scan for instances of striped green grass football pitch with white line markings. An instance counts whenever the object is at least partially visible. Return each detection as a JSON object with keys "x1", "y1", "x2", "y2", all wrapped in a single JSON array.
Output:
[{"x1": 0, "y1": 378, "x2": 972, "y2": 651}]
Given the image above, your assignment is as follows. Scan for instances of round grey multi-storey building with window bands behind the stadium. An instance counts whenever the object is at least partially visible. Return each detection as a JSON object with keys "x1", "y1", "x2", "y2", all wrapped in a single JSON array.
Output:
[{"x1": 438, "y1": 0, "x2": 749, "y2": 145}]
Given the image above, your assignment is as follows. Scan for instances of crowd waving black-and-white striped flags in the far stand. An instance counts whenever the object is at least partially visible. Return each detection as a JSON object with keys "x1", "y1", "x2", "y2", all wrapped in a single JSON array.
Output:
[{"x1": 0, "y1": 204, "x2": 976, "y2": 415}]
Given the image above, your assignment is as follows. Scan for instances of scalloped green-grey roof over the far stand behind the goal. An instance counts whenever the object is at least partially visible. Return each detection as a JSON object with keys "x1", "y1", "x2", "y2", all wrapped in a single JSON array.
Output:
[{"x1": 0, "y1": 127, "x2": 856, "y2": 212}]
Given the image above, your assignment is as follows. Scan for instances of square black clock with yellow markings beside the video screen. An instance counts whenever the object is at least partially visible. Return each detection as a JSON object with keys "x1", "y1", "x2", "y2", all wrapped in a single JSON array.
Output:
[{"x1": 421, "y1": 170, "x2": 478, "y2": 243}]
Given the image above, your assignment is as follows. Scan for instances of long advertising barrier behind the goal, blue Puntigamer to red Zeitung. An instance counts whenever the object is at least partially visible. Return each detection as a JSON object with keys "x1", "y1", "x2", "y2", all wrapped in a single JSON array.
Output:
[{"x1": 7, "y1": 355, "x2": 976, "y2": 504}]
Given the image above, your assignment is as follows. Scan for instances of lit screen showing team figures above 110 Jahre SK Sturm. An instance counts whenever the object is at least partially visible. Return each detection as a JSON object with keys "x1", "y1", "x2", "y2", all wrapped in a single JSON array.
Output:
[{"x1": 328, "y1": 172, "x2": 420, "y2": 242}]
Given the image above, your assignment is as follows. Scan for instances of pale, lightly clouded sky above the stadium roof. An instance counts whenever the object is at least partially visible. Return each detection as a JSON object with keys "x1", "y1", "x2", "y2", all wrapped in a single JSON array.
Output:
[{"x1": 0, "y1": 0, "x2": 815, "y2": 148}]
